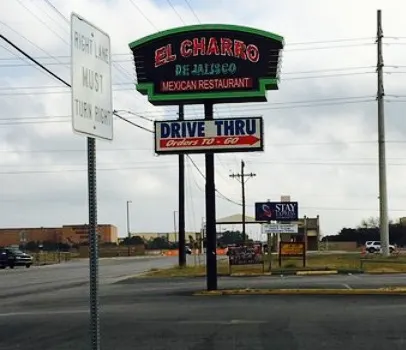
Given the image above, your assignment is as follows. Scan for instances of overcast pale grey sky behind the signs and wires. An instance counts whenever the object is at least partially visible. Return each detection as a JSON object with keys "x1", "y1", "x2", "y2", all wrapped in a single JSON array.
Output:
[{"x1": 0, "y1": 0, "x2": 406, "y2": 236}]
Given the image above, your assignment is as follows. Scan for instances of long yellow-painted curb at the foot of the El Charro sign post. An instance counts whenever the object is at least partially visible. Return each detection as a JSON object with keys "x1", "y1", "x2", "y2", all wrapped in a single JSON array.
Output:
[{"x1": 193, "y1": 287, "x2": 406, "y2": 296}]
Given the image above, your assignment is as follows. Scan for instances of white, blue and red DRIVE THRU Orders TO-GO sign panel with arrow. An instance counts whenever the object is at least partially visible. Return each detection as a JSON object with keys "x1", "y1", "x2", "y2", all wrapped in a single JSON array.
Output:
[{"x1": 154, "y1": 117, "x2": 264, "y2": 154}]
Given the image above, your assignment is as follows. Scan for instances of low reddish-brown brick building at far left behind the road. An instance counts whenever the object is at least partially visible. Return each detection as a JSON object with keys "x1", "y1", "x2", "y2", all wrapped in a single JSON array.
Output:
[{"x1": 0, "y1": 225, "x2": 118, "y2": 247}]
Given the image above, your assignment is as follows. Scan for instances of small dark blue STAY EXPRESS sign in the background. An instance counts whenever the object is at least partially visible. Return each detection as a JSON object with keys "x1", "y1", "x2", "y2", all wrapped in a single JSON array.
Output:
[{"x1": 255, "y1": 202, "x2": 299, "y2": 221}]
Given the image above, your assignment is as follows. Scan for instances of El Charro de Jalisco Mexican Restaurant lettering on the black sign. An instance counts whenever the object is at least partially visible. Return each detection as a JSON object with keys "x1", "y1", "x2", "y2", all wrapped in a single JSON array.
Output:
[{"x1": 154, "y1": 36, "x2": 261, "y2": 92}]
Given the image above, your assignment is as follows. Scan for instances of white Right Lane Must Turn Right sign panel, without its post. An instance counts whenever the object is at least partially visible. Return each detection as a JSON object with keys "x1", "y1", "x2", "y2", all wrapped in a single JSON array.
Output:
[{"x1": 71, "y1": 13, "x2": 113, "y2": 140}]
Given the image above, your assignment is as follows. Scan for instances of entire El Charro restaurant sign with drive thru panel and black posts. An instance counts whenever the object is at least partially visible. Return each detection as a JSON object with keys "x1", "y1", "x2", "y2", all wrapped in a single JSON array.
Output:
[{"x1": 129, "y1": 24, "x2": 284, "y2": 290}]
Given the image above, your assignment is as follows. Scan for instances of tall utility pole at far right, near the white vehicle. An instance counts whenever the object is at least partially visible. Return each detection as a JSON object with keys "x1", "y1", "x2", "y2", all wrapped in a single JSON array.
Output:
[{"x1": 376, "y1": 10, "x2": 390, "y2": 256}]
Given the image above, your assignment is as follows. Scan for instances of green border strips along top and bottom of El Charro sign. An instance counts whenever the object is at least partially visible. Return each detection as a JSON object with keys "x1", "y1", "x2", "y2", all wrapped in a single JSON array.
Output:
[{"x1": 129, "y1": 24, "x2": 284, "y2": 103}]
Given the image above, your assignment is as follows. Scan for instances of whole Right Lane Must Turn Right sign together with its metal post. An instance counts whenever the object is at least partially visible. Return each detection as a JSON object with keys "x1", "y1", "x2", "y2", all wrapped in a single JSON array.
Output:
[{"x1": 71, "y1": 13, "x2": 113, "y2": 350}]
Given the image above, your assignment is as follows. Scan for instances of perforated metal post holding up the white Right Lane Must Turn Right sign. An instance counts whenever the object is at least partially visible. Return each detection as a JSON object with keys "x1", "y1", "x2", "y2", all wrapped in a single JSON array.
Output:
[{"x1": 87, "y1": 137, "x2": 100, "y2": 350}]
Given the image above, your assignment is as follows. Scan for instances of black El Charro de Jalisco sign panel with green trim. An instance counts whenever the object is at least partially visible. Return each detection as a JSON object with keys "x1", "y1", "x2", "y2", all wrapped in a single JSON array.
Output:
[{"x1": 129, "y1": 24, "x2": 284, "y2": 105}]
